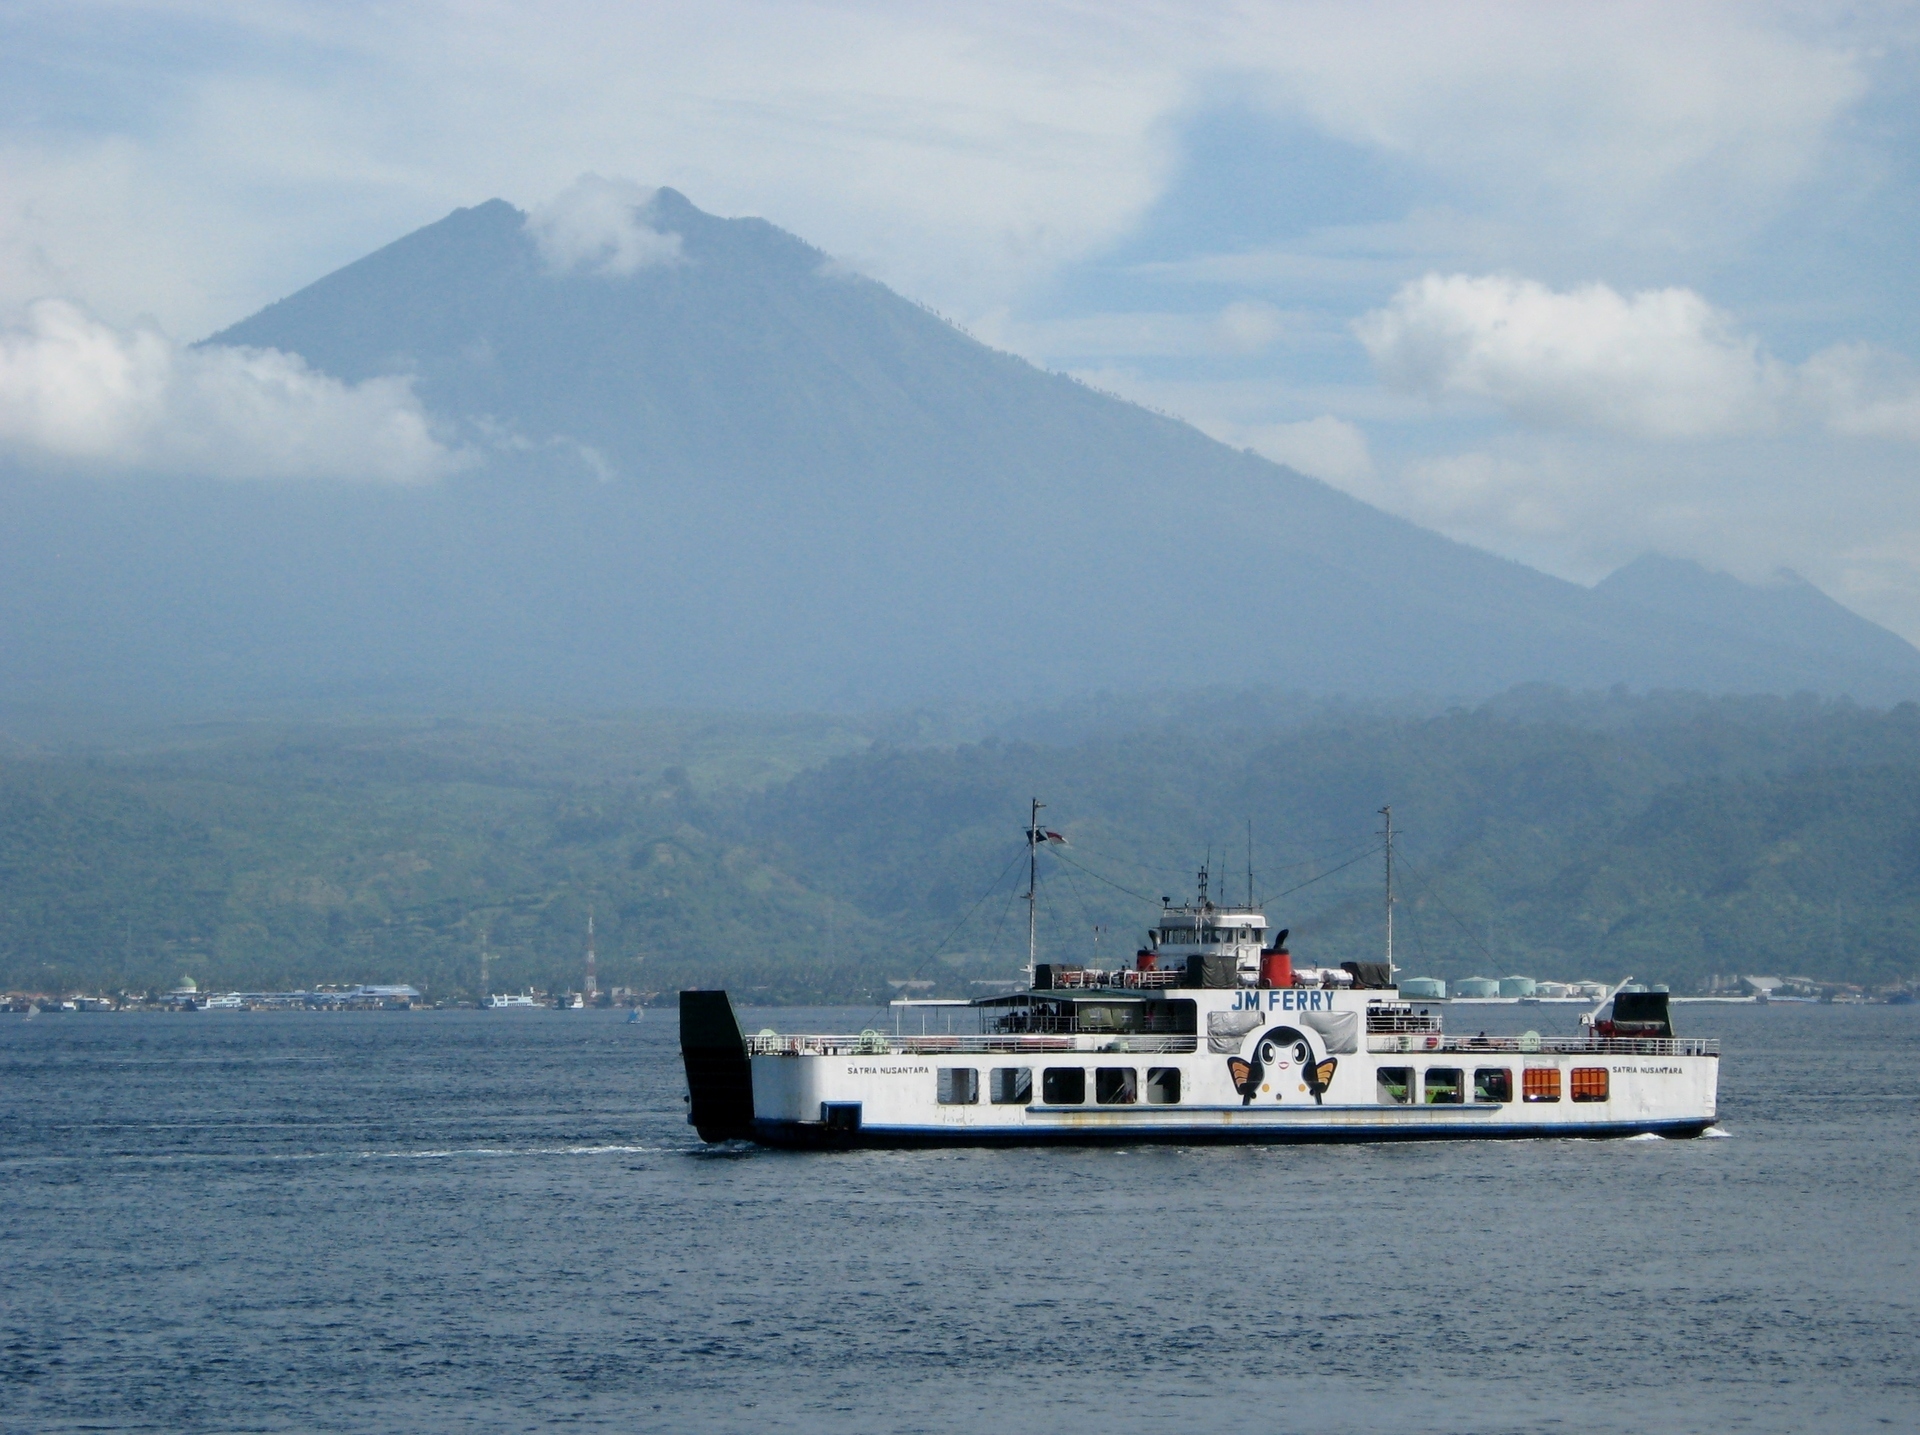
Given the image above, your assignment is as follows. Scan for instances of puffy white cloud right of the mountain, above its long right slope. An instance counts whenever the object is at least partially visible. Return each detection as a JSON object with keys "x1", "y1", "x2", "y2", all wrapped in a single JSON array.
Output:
[{"x1": 1354, "y1": 275, "x2": 1920, "y2": 442}]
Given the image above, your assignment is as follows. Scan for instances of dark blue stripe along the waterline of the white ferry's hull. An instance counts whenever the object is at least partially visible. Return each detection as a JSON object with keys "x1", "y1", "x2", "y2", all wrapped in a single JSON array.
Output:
[{"x1": 751, "y1": 1118, "x2": 1715, "y2": 1151}]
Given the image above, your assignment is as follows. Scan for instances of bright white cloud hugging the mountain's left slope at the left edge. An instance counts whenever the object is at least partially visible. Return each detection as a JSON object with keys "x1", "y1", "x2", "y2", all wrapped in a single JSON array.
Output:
[{"x1": 0, "y1": 300, "x2": 459, "y2": 482}]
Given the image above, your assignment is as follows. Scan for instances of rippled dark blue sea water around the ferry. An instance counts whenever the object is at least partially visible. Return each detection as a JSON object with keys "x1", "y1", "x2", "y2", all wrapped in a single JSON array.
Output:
[{"x1": 0, "y1": 1007, "x2": 1920, "y2": 1435}]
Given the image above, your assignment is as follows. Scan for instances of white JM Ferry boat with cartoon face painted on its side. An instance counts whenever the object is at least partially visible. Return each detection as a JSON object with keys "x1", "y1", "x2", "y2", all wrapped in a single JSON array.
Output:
[{"x1": 680, "y1": 803, "x2": 1720, "y2": 1147}]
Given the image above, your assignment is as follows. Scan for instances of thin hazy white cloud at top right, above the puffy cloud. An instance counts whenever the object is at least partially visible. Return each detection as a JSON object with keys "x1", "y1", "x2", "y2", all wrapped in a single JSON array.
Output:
[{"x1": 1219, "y1": 0, "x2": 1858, "y2": 261}]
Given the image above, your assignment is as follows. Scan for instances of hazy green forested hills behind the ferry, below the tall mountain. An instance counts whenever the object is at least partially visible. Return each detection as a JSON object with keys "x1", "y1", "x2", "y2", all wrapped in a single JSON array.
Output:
[{"x1": 0, "y1": 690, "x2": 1920, "y2": 1001}]
